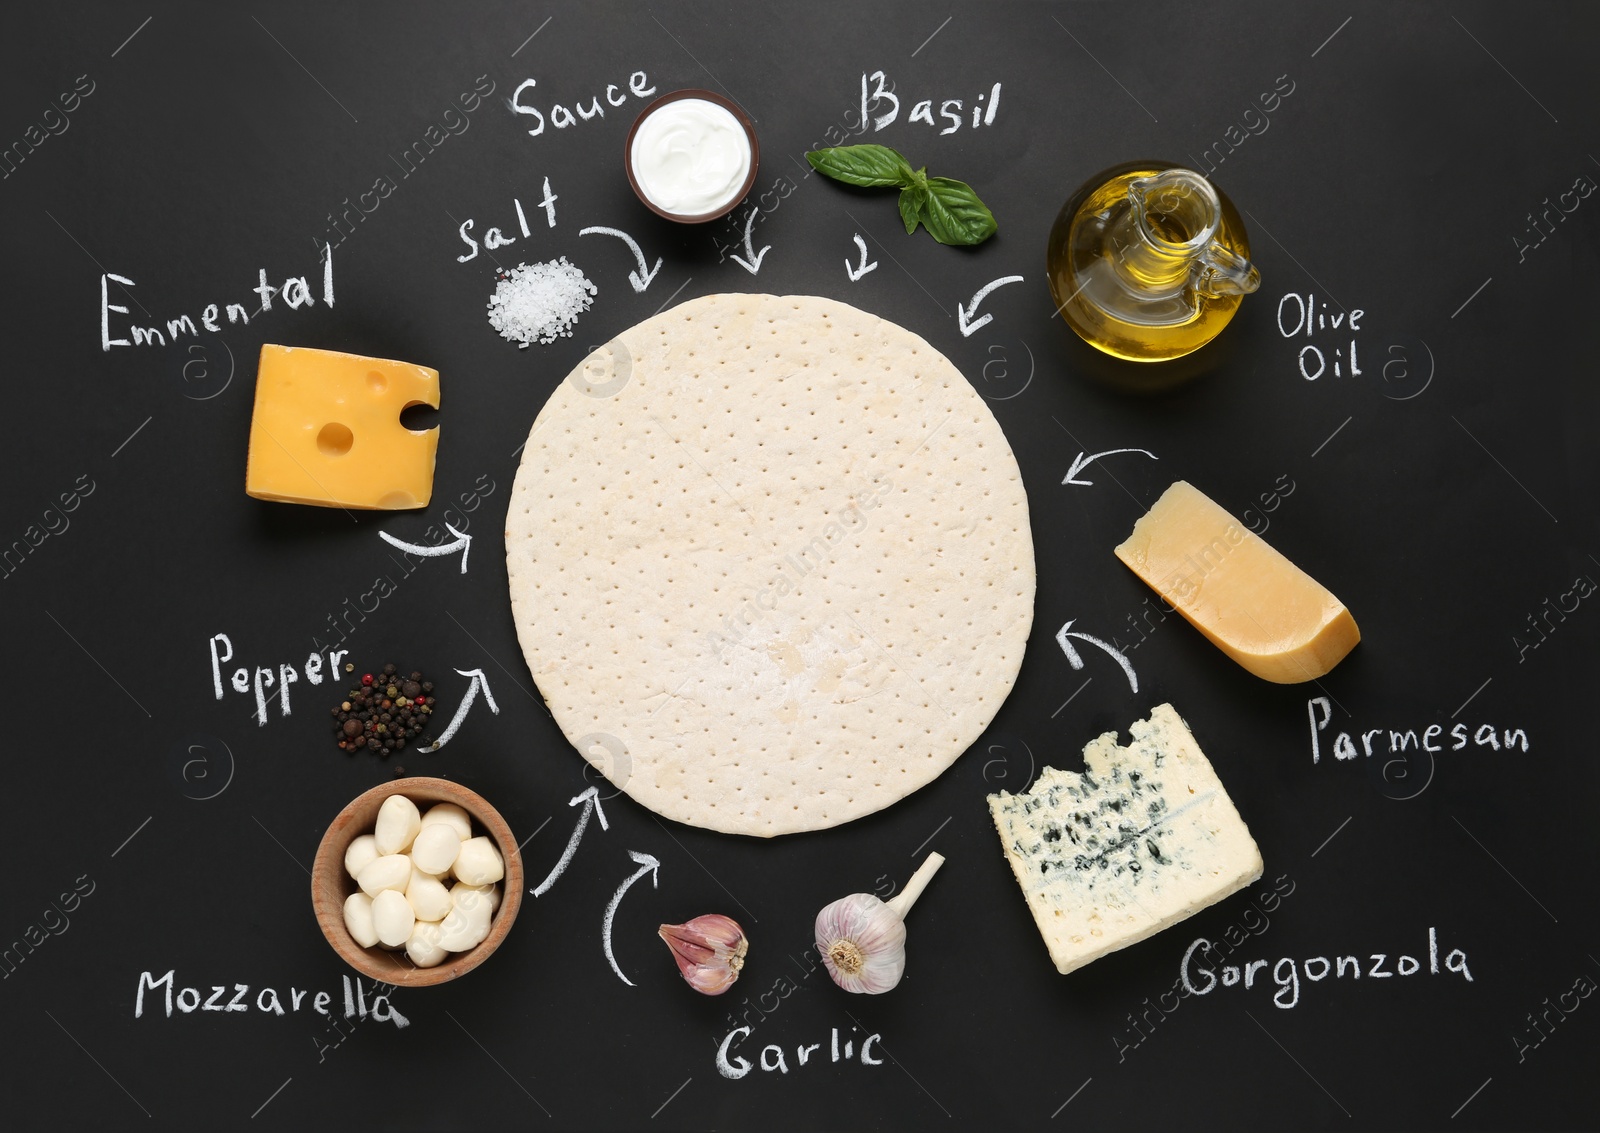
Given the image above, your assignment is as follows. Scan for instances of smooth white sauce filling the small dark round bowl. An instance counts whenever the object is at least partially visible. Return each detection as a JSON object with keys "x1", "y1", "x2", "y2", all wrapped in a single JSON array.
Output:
[{"x1": 629, "y1": 98, "x2": 752, "y2": 216}]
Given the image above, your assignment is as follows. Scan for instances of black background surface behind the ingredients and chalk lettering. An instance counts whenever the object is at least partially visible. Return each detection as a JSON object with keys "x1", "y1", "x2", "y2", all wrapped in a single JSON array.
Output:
[{"x1": 0, "y1": 3, "x2": 1600, "y2": 1130}]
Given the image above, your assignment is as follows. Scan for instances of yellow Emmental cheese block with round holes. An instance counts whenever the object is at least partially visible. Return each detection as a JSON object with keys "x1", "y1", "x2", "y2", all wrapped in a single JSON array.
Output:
[{"x1": 245, "y1": 344, "x2": 438, "y2": 510}]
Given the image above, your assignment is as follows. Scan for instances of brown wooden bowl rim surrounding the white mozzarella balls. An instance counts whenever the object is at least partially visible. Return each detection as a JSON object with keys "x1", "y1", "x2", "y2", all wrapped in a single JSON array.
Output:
[{"x1": 310, "y1": 776, "x2": 523, "y2": 987}]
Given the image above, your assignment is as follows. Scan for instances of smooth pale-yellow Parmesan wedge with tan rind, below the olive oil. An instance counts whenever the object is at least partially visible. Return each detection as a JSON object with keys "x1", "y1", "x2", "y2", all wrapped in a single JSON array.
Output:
[{"x1": 1117, "y1": 480, "x2": 1362, "y2": 685}]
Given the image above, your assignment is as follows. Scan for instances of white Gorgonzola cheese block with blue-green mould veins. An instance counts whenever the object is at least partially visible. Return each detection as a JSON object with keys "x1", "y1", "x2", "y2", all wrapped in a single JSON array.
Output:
[{"x1": 989, "y1": 704, "x2": 1261, "y2": 975}]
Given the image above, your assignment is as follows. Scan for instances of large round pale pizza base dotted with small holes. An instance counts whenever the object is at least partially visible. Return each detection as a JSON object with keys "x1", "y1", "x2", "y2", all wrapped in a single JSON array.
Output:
[{"x1": 506, "y1": 294, "x2": 1034, "y2": 835}]
